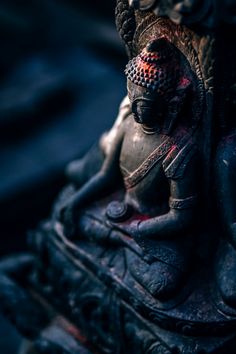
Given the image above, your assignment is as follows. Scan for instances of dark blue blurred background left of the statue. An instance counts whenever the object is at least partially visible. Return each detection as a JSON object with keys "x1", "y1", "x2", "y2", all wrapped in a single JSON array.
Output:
[{"x1": 0, "y1": 0, "x2": 127, "y2": 354}]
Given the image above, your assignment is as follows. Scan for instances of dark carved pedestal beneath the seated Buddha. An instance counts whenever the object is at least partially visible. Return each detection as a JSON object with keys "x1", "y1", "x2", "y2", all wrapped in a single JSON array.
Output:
[{"x1": 19, "y1": 224, "x2": 236, "y2": 354}]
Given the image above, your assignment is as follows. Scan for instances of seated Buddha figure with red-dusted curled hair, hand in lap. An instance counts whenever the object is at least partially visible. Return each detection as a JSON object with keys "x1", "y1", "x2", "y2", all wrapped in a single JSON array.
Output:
[{"x1": 56, "y1": 39, "x2": 198, "y2": 301}]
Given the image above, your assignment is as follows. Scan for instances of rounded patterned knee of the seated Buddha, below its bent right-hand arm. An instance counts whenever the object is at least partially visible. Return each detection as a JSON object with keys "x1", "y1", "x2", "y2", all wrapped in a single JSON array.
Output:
[{"x1": 129, "y1": 252, "x2": 184, "y2": 301}]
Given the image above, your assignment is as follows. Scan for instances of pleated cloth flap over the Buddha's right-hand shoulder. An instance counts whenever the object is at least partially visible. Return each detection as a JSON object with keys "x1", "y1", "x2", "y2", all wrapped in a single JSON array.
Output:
[{"x1": 162, "y1": 130, "x2": 198, "y2": 179}]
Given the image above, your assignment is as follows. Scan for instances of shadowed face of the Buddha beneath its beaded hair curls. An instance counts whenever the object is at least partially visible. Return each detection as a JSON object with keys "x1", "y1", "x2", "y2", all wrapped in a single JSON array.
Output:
[{"x1": 128, "y1": 80, "x2": 164, "y2": 127}]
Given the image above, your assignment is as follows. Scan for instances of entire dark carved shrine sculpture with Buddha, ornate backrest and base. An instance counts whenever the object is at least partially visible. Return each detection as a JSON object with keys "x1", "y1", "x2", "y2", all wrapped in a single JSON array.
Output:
[{"x1": 0, "y1": 0, "x2": 236, "y2": 354}]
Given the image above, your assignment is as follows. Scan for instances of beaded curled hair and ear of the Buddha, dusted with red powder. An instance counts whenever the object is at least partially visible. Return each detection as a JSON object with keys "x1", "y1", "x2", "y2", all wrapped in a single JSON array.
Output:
[{"x1": 125, "y1": 38, "x2": 192, "y2": 133}]
